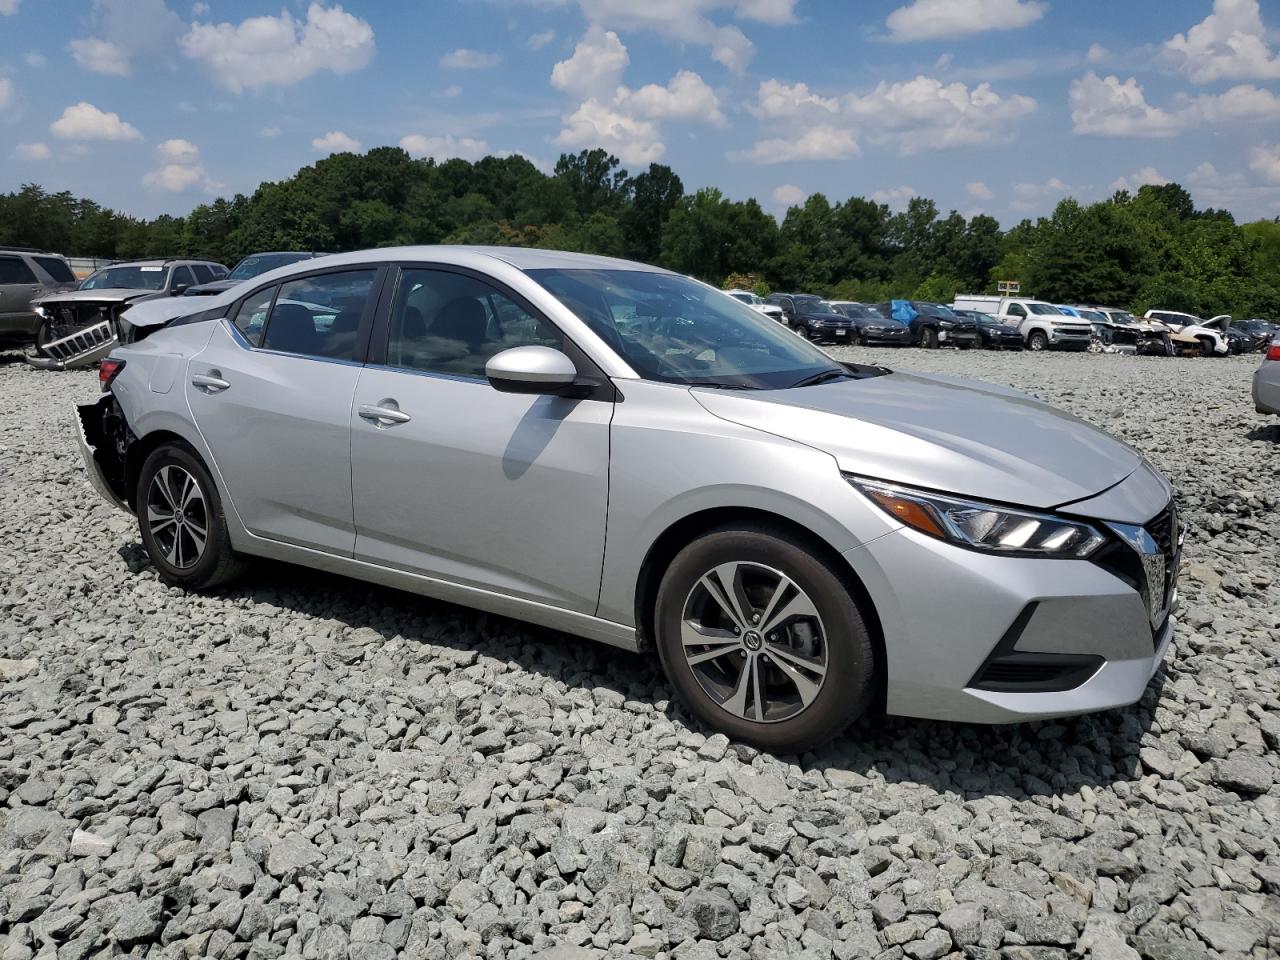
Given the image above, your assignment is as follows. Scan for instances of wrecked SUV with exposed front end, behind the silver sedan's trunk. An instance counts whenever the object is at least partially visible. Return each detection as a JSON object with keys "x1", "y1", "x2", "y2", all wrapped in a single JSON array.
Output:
[{"x1": 27, "y1": 260, "x2": 227, "y2": 370}]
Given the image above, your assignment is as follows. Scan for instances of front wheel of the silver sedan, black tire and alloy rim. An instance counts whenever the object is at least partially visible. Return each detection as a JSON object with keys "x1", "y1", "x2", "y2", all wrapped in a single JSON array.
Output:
[{"x1": 654, "y1": 526, "x2": 876, "y2": 753}]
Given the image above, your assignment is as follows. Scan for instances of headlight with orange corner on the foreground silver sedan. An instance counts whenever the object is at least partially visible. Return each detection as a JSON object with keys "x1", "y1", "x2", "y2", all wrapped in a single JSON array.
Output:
[{"x1": 846, "y1": 476, "x2": 1106, "y2": 559}]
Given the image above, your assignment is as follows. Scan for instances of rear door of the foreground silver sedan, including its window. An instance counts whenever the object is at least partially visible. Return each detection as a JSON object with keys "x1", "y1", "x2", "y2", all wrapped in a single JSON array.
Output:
[{"x1": 186, "y1": 265, "x2": 385, "y2": 557}]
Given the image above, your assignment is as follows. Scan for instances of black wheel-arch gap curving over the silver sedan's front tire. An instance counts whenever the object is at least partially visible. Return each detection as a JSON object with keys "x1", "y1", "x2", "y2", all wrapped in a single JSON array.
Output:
[{"x1": 635, "y1": 507, "x2": 886, "y2": 703}]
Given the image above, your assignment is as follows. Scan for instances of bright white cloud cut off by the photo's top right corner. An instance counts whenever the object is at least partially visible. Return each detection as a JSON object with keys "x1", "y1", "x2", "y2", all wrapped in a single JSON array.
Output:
[{"x1": 1164, "y1": 0, "x2": 1280, "y2": 83}]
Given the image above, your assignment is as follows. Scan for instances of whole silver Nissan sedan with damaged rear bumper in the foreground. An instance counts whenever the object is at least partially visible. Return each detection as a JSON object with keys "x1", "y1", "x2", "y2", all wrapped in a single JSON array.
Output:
[{"x1": 78, "y1": 247, "x2": 1181, "y2": 751}]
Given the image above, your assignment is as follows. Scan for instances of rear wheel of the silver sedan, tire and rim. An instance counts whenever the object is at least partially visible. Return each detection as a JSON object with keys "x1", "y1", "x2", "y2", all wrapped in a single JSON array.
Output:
[{"x1": 134, "y1": 443, "x2": 243, "y2": 590}]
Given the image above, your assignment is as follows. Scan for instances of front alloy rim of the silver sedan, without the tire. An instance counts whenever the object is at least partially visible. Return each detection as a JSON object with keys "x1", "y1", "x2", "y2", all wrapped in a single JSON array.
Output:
[{"x1": 680, "y1": 562, "x2": 828, "y2": 723}]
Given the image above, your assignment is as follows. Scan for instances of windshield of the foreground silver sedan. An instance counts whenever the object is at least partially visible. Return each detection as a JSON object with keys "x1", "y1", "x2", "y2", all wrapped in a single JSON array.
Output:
[{"x1": 529, "y1": 270, "x2": 844, "y2": 389}]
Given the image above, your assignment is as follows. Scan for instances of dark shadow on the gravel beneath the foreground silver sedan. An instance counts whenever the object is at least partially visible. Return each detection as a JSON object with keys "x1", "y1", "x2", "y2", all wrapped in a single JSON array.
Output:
[{"x1": 119, "y1": 543, "x2": 1166, "y2": 800}]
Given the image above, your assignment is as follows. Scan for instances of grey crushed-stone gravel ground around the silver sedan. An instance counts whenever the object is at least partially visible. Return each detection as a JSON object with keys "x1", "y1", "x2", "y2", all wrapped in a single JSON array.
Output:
[{"x1": 0, "y1": 349, "x2": 1280, "y2": 960}]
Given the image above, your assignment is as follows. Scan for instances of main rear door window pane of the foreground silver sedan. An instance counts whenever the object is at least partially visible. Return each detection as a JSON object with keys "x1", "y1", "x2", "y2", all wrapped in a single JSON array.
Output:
[{"x1": 262, "y1": 268, "x2": 378, "y2": 360}]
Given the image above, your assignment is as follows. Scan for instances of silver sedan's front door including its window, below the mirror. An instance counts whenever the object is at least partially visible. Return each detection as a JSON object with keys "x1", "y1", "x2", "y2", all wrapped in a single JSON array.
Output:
[{"x1": 351, "y1": 268, "x2": 613, "y2": 614}]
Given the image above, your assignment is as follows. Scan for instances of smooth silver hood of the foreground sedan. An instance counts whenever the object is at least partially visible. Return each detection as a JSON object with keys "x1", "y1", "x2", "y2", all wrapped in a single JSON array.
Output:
[{"x1": 692, "y1": 372, "x2": 1142, "y2": 508}]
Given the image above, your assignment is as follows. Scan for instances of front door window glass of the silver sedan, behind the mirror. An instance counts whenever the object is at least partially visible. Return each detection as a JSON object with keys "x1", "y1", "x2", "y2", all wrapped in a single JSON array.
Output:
[{"x1": 387, "y1": 270, "x2": 564, "y2": 376}]
